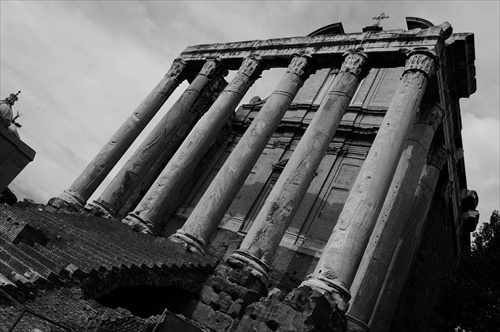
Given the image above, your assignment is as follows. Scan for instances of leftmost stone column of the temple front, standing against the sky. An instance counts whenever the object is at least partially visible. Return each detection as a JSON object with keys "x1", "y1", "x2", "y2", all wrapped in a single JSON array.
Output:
[{"x1": 48, "y1": 59, "x2": 188, "y2": 209}]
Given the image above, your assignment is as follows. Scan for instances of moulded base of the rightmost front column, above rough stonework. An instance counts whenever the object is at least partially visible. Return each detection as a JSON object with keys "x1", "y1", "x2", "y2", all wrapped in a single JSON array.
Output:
[{"x1": 299, "y1": 274, "x2": 351, "y2": 311}]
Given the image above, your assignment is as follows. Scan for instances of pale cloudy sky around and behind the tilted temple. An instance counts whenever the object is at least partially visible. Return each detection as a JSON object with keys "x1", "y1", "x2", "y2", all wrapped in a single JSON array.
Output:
[{"x1": 0, "y1": 0, "x2": 500, "y2": 226}]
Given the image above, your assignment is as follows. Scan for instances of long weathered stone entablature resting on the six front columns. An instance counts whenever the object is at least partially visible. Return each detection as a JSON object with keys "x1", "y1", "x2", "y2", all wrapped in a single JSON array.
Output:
[{"x1": 179, "y1": 22, "x2": 451, "y2": 70}]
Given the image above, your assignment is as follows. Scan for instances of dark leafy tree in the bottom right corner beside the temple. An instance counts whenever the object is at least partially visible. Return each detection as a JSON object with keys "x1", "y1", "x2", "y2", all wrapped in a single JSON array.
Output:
[{"x1": 434, "y1": 210, "x2": 500, "y2": 332}]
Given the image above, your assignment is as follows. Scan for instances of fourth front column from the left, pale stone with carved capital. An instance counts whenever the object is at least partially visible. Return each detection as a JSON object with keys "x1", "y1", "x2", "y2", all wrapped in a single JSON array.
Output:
[{"x1": 170, "y1": 55, "x2": 314, "y2": 252}]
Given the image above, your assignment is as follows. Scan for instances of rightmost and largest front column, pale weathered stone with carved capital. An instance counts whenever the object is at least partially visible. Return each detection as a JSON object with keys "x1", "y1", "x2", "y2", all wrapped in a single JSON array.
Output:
[{"x1": 303, "y1": 50, "x2": 436, "y2": 299}]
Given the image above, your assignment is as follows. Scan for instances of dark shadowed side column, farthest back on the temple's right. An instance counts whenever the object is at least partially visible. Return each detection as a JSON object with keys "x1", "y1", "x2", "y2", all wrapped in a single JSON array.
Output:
[{"x1": 369, "y1": 146, "x2": 449, "y2": 332}]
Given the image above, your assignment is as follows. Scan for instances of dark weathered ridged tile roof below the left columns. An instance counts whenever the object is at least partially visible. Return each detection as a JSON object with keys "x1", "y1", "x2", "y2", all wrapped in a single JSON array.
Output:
[{"x1": 0, "y1": 205, "x2": 217, "y2": 299}]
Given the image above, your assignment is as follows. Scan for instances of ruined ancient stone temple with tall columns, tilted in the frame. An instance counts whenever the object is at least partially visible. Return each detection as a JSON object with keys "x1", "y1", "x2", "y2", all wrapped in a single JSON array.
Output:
[{"x1": 2, "y1": 18, "x2": 478, "y2": 331}]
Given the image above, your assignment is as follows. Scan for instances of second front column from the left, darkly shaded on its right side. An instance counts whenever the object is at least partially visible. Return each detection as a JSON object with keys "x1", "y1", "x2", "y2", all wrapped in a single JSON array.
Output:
[{"x1": 91, "y1": 59, "x2": 227, "y2": 218}]
